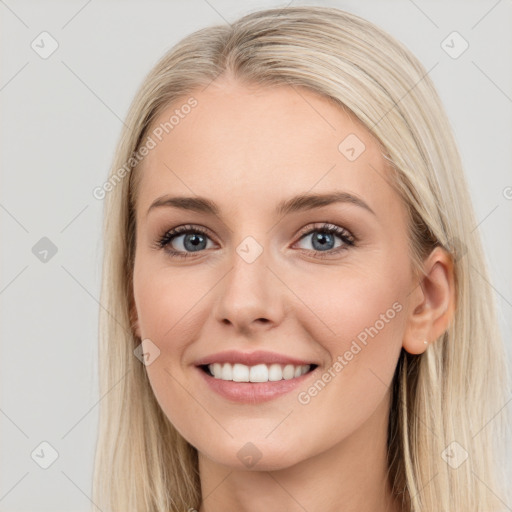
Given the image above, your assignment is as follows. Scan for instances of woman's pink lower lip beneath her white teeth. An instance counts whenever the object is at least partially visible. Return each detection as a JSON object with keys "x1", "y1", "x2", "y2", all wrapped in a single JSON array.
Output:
[{"x1": 196, "y1": 366, "x2": 318, "y2": 404}]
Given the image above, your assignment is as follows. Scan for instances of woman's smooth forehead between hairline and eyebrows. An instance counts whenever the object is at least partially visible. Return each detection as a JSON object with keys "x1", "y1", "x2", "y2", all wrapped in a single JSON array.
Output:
[{"x1": 137, "y1": 81, "x2": 397, "y2": 219}]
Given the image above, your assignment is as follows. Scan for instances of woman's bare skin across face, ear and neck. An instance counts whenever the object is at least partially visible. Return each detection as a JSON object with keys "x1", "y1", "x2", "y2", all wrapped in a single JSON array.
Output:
[{"x1": 132, "y1": 78, "x2": 454, "y2": 512}]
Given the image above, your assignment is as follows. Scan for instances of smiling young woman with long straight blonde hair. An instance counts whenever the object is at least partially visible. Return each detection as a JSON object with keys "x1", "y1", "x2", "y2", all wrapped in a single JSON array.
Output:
[{"x1": 94, "y1": 7, "x2": 507, "y2": 512}]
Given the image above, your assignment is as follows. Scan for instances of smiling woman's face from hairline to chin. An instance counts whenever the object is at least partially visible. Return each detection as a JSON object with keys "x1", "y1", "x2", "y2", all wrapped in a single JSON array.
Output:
[{"x1": 134, "y1": 81, "x2": 417, "y2": 470}]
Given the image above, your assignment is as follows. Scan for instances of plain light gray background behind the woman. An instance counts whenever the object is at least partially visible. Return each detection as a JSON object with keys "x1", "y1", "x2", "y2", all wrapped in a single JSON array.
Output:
[{"x1": 0, "y1": 0, "x2": 512, "y2": 512}]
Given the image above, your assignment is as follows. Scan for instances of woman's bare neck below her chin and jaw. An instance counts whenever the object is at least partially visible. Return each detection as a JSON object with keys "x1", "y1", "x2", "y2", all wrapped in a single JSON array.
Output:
[{"x1": 199, "y1": 397, "x2": 401, "y2": 512}]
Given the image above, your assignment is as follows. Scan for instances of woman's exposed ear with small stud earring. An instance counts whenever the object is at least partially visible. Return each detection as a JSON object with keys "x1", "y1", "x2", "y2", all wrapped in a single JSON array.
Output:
[{"x1": 403, "y1": 247, "x2": 455, "y2": 354}]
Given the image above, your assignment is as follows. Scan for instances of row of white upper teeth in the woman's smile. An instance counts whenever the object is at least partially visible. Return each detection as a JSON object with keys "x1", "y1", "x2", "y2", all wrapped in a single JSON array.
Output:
[{"x1": 208, "y1": 363, "x2": 311, "y2": 382}]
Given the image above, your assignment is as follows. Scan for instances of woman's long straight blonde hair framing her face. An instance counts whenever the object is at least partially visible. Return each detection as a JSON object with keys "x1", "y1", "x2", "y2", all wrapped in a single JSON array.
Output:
[{"x1": 93, "y1": 6, "x2": 509, "y2": 512}]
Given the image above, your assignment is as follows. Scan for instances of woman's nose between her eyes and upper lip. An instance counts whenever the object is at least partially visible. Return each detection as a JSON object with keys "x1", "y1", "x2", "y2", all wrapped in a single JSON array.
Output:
[{"x1": 214, "y1": 244, "x2": 285, "y2": 335}]
